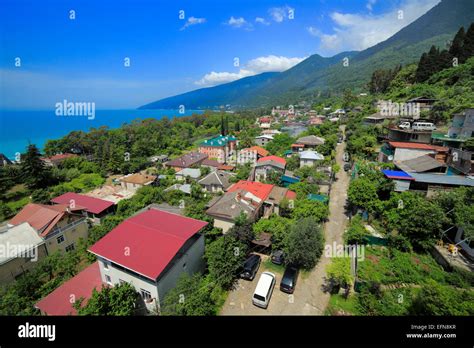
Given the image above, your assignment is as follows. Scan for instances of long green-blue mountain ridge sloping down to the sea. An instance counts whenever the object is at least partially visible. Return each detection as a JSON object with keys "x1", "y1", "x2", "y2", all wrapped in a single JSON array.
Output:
[{"x1": 141, "y1": 0, "x2": 474, "y2": 109}]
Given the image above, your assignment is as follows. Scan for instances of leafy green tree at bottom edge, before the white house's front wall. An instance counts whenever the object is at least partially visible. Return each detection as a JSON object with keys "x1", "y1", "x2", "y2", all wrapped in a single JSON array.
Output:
[{"x1": 74, "y1": 283, "x2": 139, "y2": 316}]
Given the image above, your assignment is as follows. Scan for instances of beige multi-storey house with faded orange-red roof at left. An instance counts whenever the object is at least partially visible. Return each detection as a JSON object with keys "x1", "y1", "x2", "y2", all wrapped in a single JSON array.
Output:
[{"x1": 8, "y1": 203, "x2": 89, "y2": 254}]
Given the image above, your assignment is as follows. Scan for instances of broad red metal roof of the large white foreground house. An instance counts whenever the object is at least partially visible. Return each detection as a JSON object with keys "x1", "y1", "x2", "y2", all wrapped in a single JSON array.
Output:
[{"x1": 89, "y1": 209, "x2": 208, "y2": 280}]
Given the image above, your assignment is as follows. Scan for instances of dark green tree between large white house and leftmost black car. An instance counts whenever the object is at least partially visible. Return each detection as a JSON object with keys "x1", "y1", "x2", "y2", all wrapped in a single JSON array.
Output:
[{"x1": 205, "y1": 234, "x2": 247, "y2": 290}]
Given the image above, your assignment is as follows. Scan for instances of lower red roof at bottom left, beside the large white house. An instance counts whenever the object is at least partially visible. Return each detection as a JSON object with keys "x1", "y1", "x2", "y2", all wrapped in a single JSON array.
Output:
[{"x1": 35, "y1": 261, "x2": 102, "y2": 315}]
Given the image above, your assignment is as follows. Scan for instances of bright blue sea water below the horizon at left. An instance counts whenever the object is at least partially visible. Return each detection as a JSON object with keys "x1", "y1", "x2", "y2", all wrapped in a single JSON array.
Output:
[{"x1": 0, "y1": 109, "x2": 202, "y2": 159}]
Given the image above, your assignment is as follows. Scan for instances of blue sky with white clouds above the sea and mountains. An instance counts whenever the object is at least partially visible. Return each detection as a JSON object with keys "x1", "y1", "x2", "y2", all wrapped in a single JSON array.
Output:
[{"x1": 0, "y1": 0, "x2": 439, "y2": 110}]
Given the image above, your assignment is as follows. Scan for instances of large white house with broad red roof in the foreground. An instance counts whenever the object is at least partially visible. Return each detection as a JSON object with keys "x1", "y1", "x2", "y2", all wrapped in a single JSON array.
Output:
[{"x1": 89, "y1": 206, "x2": 208, "y2": 310}]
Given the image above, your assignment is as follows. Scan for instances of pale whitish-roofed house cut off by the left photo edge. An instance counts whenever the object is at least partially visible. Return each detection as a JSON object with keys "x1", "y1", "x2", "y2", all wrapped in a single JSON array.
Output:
[{"x1": 0, "y1": 222, "x2": 48, "y2": 285}]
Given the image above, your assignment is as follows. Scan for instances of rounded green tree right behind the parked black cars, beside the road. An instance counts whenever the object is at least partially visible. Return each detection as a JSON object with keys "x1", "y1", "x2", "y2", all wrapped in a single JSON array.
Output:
[{"x1": 285, "y1": 217, "x2": 324, "y2": 269}]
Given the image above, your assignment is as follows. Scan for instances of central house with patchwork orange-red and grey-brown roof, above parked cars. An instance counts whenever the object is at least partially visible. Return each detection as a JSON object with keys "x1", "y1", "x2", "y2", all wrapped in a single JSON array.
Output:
[{"x1": 206, "y1": 180, "x2": 296, "y2": 233}]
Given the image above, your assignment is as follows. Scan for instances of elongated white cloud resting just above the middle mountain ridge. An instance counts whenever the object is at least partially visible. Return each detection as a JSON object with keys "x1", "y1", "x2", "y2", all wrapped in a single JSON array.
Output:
[{"x1": 195, "y1": 55, "x2": 306, "y2": 87}]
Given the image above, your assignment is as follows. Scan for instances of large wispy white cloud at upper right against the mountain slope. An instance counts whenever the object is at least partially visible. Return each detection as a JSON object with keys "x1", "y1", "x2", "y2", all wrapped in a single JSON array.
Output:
[{"x1": 307, "y1": 0, "x2": 440, "y2": 54}]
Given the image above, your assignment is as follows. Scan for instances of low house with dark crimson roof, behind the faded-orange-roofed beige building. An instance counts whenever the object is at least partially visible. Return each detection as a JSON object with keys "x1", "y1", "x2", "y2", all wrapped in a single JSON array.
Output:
[{"x1": 51, "y1": 192, "x2": 115, "y2": 223}]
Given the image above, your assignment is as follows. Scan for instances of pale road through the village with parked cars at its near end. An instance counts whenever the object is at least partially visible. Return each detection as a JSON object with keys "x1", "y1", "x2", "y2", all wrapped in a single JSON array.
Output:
[{"x1": 221, "y1": 127, "x2": 349, "y2": 315}]
